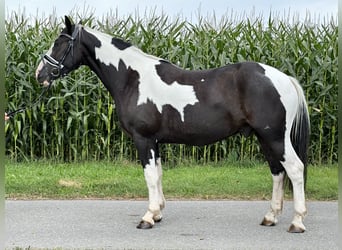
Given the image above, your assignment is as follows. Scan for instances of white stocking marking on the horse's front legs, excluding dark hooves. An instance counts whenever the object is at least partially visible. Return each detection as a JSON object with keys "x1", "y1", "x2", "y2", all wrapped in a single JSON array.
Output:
[{"x1": 142, "y1": 149, "x2": 162, "y2": 225}]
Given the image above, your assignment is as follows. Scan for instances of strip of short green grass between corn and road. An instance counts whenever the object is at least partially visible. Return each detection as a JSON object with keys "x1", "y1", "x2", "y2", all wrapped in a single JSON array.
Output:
[{"x1": 5, "y1": 162, "x2": 338, "y2": 200}]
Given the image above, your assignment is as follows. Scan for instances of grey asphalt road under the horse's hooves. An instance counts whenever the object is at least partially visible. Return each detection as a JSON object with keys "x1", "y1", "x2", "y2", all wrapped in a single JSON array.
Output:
[{"x1": 5, "y1": 200, "x2": 338, "y2": 250}]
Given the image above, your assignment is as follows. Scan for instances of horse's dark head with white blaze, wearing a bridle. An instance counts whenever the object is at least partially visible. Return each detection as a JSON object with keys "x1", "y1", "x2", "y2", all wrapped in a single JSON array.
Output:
[{"x1": 36, "y1": 16, "x2": 83, "y2": 86}]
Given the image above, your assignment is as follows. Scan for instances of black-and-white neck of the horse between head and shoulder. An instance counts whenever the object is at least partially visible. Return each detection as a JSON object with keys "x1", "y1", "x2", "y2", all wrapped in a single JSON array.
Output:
[{"x1": 82, "y1": 28, "x2": 160, "y2": 101}]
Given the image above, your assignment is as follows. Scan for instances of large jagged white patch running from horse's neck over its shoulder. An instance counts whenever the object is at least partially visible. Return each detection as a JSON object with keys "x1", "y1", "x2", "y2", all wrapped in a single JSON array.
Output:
[{"x1": 85, "y1": 28, "x2": 198, "y2": 121}]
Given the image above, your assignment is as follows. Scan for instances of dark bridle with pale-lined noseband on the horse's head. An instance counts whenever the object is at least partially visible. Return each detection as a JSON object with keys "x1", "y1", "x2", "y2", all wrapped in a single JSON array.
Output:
[{"x1": 42, "y1": 27, "x2": 79, "y2": 78}]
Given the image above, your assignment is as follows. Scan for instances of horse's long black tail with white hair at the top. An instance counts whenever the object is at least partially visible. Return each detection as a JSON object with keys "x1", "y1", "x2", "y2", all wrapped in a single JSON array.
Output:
[{"x1": 290, "y1": 77, "x2": 310, "y2": 187}]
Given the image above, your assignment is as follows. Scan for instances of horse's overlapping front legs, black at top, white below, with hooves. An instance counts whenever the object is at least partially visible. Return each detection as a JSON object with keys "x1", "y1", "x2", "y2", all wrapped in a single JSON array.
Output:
[{"x1": 137, "y1": 139, "x2": 165, "y2": 229}]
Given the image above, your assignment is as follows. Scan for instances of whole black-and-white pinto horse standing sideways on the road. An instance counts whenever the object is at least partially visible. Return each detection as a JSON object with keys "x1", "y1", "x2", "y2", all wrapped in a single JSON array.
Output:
[{"x1": 36, "y1": 17, "x2": 310, "y2": 232}]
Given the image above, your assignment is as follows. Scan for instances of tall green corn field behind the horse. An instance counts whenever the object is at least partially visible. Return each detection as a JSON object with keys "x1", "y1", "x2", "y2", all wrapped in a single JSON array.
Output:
[{"x1": 5, "y1": 12, "x2": 338, "y2": 164}]
